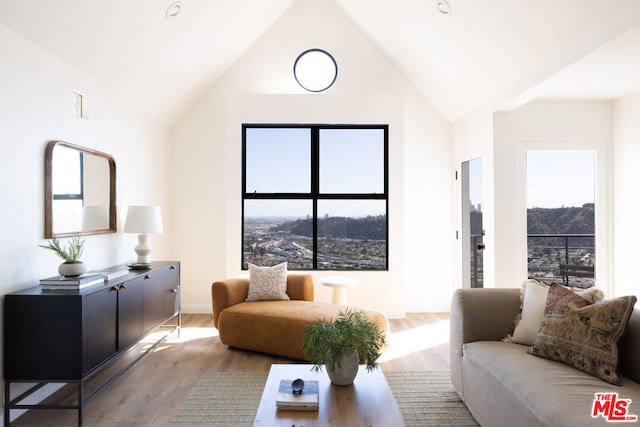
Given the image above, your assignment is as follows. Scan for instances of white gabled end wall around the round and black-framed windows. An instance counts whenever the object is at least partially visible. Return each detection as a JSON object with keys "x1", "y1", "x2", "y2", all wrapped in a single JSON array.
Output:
[{"x1": 170, "y1": 1, "x2": 453, "y2": 316}]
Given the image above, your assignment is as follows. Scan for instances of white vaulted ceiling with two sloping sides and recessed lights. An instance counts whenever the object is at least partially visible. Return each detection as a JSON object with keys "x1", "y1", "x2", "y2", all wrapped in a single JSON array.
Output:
[{"x1": 0, "y1": 0, "x2": 640, "y2": 121}]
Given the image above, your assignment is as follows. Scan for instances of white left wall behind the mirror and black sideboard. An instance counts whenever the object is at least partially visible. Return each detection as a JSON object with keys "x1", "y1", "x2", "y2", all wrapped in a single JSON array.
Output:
[{"x1": 0, "y1": 25, "x2": 170, "y2": 424}]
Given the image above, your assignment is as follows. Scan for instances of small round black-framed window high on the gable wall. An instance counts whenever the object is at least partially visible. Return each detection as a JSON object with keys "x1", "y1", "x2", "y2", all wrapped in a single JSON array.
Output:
[{"x1": 293, "y1": 49, "x2": 338, "y2": 92}]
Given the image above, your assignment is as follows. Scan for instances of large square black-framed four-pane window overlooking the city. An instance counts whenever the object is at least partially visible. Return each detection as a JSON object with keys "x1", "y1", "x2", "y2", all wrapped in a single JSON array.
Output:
[{"x1": 242, "y1": 124, "x2": 389, "y2": 270}]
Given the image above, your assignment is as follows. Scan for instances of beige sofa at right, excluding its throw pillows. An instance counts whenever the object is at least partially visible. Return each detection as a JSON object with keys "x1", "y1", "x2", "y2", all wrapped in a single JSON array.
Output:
[{"x1": 450, "y1": 289, "x2": 640, "y2": 427}]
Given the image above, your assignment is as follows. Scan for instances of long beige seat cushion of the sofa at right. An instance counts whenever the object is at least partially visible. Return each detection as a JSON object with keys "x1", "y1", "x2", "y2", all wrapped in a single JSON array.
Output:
[{"x1": 463, "y1": 341, "x2": 640, "y2": 427}]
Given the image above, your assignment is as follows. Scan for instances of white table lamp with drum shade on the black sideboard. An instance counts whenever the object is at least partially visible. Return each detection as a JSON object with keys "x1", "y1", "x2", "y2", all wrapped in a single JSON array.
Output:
[{"x1": 124, "y1": 206, "x2": 163, "y2": 265}]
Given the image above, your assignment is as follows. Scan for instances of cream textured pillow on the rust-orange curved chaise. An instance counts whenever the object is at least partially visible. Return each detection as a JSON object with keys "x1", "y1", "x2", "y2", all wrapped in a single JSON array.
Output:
[{"x1": 246, "y1": 262, "x2": 289, "y2": 301}]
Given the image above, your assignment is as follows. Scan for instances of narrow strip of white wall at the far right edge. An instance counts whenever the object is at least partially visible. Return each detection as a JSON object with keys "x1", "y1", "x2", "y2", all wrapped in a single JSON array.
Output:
[{"x1": 612, "y1": 92, "x2": 640, "y2": 295}]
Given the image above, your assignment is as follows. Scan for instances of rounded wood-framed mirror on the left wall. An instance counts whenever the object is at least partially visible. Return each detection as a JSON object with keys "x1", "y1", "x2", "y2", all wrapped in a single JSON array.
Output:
[{"x1": 44, "y1": 141, "x2": 117, "y2": 239}]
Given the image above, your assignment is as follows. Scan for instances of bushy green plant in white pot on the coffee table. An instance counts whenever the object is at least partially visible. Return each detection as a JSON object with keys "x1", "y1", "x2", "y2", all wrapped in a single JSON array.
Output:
[{"x1": 302, "y1": 309, "x2": 386, "y2": 385}]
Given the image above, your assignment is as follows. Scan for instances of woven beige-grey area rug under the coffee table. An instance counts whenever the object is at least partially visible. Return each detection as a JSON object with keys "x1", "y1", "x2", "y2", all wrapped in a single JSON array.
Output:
[{"x1": 169, "y1": 371, "x2": 478, "y2": 427}]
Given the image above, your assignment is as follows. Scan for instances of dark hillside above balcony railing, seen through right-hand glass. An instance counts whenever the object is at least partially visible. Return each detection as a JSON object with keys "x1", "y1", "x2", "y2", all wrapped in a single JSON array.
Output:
[{"x1": 527, "y1": 203, "x2": 595, "y2": 234}]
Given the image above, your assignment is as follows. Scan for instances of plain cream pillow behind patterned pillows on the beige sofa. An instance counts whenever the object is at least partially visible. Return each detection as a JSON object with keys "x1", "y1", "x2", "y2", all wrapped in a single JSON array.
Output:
[{"x1": 507, "y1": 279, "x2": 604, "y2": 345}]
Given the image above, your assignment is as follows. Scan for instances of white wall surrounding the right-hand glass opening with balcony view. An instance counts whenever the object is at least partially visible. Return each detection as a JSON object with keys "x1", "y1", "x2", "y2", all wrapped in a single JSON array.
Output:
[{"x1": 493, "y1": 101, "x2": 613, "y2": 294}]
